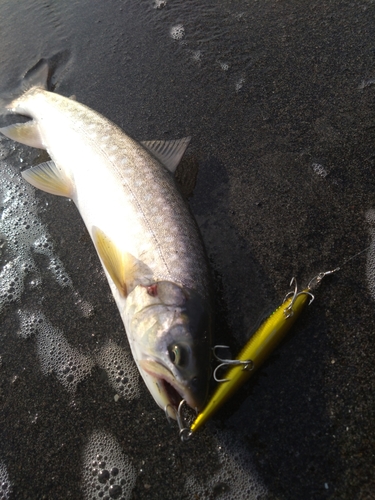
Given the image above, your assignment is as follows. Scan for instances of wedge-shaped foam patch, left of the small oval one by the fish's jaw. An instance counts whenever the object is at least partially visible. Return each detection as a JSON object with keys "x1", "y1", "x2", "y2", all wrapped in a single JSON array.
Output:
[{"x1": 36, "y1": 312, "x2": 94, "y2": 393}]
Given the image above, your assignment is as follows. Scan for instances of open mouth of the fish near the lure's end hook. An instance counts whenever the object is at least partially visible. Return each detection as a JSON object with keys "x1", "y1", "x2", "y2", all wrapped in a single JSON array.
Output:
[{"x1": 139, "y1": 359, "x2": 189, "y2": 419}]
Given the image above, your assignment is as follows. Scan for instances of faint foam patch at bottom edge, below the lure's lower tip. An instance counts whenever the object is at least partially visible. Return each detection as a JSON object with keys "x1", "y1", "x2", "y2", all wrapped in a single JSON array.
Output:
[{"x1": 185, "y1": 424, "x2": 266, "y2": 500}]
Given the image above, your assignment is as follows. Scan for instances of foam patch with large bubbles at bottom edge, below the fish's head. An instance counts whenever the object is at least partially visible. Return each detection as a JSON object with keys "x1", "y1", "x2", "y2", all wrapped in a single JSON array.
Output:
[{"x1": 82, "y1": 431, "x2": 137, "y2": 500}]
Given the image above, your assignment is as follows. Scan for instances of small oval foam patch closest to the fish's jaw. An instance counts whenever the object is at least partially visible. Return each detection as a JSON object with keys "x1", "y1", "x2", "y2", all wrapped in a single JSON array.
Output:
[{"x1": 97, "y1": 341, "x2": 140, "y2": 401}]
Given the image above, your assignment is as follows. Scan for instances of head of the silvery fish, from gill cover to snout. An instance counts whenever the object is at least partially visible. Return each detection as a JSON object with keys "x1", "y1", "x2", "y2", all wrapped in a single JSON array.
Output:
[{"x1": 125, "y1": 281, "x2": 211, "y2": 418}]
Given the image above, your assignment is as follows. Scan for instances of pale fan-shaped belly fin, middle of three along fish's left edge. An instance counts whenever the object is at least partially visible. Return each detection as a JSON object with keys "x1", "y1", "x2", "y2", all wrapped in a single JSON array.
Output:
[{"x1": 22, "y1": 161, "x2": 73, "y2": 198}]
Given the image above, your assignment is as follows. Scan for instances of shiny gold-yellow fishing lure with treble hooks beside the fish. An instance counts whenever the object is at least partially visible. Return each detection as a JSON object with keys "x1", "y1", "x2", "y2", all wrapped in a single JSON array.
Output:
[{"x1": 177, "y1": 268, "x2": 339, "y2": 441}]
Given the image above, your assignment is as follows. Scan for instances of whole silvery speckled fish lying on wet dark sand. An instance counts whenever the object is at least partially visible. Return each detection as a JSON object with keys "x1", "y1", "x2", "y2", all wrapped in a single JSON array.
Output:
[{"x1": 0, "y1": 59, "x2": 212, "y2": 419}]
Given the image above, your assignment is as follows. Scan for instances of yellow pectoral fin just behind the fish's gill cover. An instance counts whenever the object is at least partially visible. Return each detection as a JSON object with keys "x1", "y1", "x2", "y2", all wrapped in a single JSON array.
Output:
[{"x1": 92, "y1": 227, "x2": 151, "y2": 297}]
